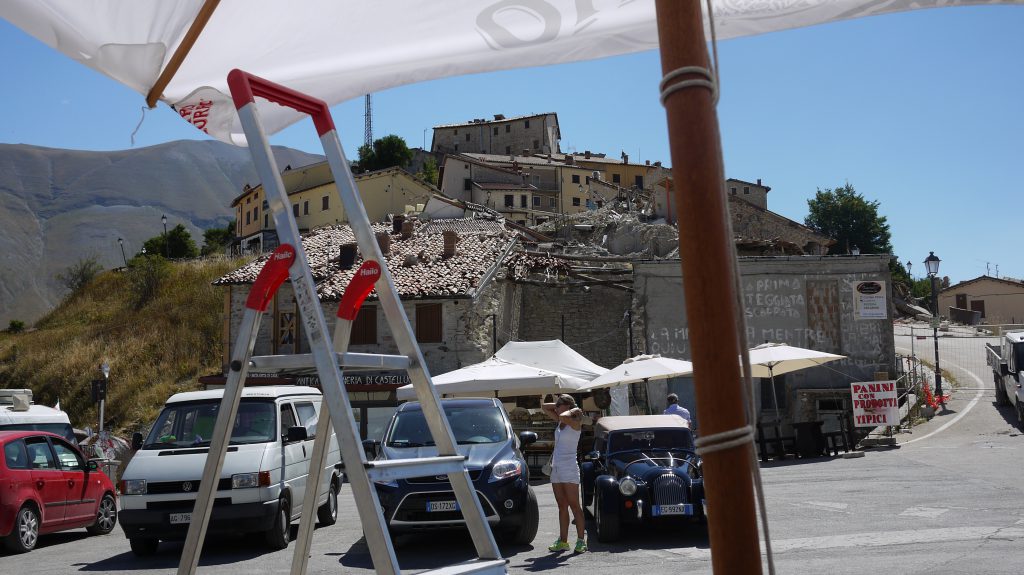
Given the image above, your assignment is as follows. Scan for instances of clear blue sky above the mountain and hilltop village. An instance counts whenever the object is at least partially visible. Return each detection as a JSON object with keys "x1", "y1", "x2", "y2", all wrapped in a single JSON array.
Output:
[{"x1": 0, "y1": 6, "x2": 1024, "y2": 282}]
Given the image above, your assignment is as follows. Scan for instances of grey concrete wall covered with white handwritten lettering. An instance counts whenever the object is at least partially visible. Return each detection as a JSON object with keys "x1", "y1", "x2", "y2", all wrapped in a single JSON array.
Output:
[{"x1": 634, "y1": 256, "x2": 895, "y2": 421}]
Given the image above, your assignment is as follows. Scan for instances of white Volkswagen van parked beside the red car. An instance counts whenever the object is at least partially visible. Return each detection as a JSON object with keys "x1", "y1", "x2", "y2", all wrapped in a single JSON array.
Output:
[{"x1": 119, "y1": 386, "x2": 342, "y2": 556}]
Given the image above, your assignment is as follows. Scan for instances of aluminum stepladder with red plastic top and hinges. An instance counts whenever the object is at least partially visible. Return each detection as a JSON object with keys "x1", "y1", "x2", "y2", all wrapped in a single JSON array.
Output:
[{"x1": 178, "y1": 70, "x2": 507, "y2": 575}]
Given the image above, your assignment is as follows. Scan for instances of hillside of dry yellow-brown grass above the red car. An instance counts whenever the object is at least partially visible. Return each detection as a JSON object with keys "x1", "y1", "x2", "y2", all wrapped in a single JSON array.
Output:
[{"x1": 0, "y1": 258, "x2": 245, "y2": 433}]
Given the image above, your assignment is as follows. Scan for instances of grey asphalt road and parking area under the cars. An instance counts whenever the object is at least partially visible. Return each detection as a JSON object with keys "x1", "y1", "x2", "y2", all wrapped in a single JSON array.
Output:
[{"x1": 0, "y1": 323, "x2": 1024, "y2": 575}]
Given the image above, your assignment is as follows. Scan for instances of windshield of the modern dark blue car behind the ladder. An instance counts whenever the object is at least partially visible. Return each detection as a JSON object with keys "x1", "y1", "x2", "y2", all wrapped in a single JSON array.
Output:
[{"x1": 386, "y1": 405, "x2": 508, "y2": 447}]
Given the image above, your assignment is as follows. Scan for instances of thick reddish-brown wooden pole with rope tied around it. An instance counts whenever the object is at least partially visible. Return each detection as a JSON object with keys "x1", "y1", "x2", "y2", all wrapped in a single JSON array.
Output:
[{"x1": 655, "y1": 0, "x2": 761, "y2": 575}]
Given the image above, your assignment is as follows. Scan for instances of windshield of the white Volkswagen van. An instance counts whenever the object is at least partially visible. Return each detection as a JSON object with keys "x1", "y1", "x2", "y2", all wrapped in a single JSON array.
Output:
[{"x1": 142, "y1": 399, "x2": 278, "y2": 449}]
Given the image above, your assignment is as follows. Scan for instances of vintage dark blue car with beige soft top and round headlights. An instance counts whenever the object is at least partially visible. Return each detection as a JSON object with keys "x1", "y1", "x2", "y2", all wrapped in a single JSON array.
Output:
[{"x1": 581, "y1": 415, "x2": 707, "y2": 541}]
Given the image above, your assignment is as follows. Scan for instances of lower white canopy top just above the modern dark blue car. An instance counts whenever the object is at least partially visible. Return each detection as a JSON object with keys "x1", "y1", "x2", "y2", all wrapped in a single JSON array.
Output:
[{"x1": 397, "y1": 357, "x2": 587, "y2": 400}]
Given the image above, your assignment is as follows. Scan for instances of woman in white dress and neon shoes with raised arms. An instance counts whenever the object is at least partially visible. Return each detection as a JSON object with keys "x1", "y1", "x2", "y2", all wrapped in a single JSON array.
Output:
[{"x1": 541, "y1": 395, "x2": 587, "y2": 554}]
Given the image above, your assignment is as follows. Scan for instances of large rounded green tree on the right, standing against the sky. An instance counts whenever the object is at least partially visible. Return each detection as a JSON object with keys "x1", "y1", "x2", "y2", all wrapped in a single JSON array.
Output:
[{"x1": 804, "y1": 183, "x2": 893, "y2": 255}]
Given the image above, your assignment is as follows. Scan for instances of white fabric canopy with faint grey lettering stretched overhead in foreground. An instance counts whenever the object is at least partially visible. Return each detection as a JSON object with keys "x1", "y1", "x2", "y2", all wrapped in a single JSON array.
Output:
[{"x1": 6, "y1": 0, "x2": 1024, "y2": 145}]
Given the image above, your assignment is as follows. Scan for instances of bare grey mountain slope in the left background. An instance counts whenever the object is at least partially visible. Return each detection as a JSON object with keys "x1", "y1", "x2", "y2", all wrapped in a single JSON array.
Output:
[{"x1": 0, "y1": 140, "x2": 322, "y2": 328}]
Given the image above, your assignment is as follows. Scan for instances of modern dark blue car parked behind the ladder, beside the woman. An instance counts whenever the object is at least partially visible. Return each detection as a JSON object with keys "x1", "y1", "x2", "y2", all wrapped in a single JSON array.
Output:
[{"x1": 364, "y1": 398, "x2": 540, "y2": 545}]
